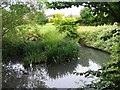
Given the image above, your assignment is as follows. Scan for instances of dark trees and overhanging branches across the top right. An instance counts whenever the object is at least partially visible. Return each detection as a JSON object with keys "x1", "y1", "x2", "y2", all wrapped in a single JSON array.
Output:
[{"x1": 46, "y1": 2, "x2": 120, "y2": 25}]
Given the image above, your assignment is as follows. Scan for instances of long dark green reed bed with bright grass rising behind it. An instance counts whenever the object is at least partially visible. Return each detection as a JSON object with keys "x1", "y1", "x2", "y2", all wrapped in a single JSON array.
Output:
[{"x1": 25, "y1": 31, "x2": 79, "y2": 63}]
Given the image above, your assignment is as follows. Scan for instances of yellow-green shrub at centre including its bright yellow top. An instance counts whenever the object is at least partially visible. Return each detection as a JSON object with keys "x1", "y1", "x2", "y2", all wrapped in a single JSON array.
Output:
[{"x1": 50, "y1": 14, "x2": 79, "y2": 39}]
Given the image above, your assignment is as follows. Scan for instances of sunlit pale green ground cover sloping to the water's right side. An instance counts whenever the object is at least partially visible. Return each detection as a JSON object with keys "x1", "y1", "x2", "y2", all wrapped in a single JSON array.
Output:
[{"x1": 78, "y1": 25, "x2": 120, "y2": 53}]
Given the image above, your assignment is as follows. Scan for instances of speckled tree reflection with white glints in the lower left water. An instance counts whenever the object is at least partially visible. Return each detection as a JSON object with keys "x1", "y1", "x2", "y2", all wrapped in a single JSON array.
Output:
[{"x1": 2, "y1": 63, "x2": 47, "y2": 88}]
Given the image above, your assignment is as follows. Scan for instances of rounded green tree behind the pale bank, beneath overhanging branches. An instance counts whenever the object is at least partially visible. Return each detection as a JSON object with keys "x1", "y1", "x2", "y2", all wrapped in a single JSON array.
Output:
[{"x1": 78, "y1": 7, "x2": 114, "y2": 26}]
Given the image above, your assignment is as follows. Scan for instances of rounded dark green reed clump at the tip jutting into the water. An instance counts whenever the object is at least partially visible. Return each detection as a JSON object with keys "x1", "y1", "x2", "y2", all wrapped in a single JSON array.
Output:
[{"x1": 47, "y1": 40, "x2": 79, "y2": 63}]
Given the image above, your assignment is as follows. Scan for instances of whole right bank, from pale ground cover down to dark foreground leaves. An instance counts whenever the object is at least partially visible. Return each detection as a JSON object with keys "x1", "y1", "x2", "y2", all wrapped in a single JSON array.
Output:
[{"x1": 78, "y1": 25, "x2": 120, "y2": 90}]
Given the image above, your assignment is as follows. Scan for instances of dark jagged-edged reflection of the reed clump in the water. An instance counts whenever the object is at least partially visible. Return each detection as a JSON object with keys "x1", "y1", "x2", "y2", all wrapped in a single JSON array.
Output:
[{"x1": 47, "y1": 60, "x2": 78, "y2": 79}]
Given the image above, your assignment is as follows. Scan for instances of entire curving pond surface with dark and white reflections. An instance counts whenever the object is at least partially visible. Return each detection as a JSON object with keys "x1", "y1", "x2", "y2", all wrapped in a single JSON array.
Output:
[{"x1": 2, "y1": 47, "x2": 110, "y2": 88}]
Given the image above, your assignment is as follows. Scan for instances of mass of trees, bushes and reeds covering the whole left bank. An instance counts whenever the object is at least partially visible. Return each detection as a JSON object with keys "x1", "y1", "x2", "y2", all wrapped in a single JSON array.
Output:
[{"x1": 1, "y1": 1, "x2": 79, "y2": 64}]
